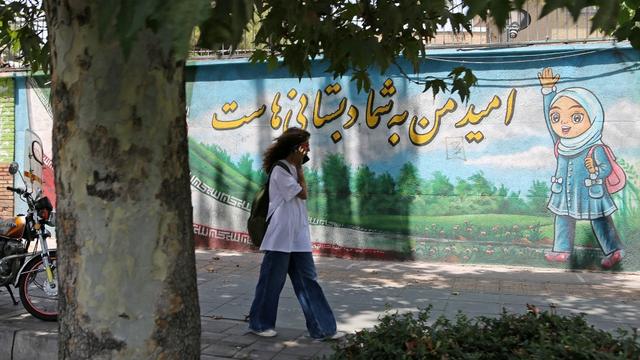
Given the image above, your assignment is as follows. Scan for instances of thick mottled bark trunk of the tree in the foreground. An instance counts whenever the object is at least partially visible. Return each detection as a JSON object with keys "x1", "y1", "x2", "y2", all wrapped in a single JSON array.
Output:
[{"x1": 45, "y1": 0, "x2": 206, "y2": 359}]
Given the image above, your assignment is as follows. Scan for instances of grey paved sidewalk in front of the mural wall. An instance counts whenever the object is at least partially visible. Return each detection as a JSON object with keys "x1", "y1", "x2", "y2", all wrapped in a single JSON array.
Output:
[{"x1": 0, "y1": 250, "x2": 640, "y2": 360}]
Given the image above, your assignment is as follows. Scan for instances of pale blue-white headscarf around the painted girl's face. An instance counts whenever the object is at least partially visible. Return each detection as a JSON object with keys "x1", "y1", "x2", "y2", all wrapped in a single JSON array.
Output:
[{"x1": 551, "y1": 87, "x2": 604, "y2": 156}]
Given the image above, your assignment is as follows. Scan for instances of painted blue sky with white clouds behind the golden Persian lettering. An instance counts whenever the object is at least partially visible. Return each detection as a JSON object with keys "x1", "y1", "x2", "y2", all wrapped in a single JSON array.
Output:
[{"x1": 189, "y1": 45, "x2": 640, "y2": 194}]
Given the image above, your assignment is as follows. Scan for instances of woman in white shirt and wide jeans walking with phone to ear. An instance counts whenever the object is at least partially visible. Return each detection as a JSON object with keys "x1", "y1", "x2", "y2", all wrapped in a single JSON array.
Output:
[{"x1": 249, "y1": 128, "x2": 344, "y2": 340}]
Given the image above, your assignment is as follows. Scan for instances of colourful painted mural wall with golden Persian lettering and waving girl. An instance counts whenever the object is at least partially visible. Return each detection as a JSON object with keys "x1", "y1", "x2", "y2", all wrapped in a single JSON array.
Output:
[{"x1": 187, "y1": 45, "x2": 640, "y2": 271}]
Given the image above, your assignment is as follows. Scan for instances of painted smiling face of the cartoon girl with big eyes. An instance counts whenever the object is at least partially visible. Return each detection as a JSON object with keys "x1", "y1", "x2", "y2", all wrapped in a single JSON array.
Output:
[{"x1": 549, "y1": 96, "x2": 591, "y2": 139}]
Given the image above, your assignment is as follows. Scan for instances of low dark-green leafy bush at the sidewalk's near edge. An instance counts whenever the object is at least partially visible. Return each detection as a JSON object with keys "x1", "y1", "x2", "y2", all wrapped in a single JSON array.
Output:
[{"x1": 330, "y1": 306, "x2": 640, "y2": 360}]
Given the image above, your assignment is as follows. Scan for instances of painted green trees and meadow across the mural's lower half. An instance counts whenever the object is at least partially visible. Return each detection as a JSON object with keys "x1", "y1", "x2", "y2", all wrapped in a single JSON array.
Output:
[{"x1": 189, "y1": 139, "x2": 640, "y2": 270}]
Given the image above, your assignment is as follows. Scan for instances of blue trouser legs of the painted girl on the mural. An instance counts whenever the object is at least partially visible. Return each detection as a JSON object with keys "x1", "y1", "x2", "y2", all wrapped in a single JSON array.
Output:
[{"x1": 553, "y1": 215, "x2": 622, "y2": 255}]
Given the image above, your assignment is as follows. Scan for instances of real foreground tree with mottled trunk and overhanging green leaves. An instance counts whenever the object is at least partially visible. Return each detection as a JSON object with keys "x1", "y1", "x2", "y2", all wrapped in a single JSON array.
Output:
[{"x1": 0, "y1": 0, "x2": 640, "y2": 359}]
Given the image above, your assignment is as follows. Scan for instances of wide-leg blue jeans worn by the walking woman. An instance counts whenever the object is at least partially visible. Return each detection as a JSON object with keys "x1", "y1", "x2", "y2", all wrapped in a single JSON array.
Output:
[{"x1": 249, "y1": 251, "x2": 336, "y2": 339}]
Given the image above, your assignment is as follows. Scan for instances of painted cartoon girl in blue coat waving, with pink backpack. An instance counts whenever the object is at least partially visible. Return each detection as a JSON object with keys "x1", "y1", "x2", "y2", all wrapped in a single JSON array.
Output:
[{"x1": 538, "y1": 68, "x2": 624, "y2": 269}]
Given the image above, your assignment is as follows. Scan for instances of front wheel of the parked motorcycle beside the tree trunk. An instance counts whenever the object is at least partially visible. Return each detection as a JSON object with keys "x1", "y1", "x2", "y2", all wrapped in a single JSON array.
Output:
[{"x1": 18, "y1": 251, "x2": 58, "y2": 321}]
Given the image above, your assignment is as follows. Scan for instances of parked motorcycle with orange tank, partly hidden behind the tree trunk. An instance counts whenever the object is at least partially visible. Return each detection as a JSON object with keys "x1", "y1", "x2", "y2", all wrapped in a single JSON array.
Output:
[{"x1": 0, "y1": 162, "x2": 58, "y2": 321}]
